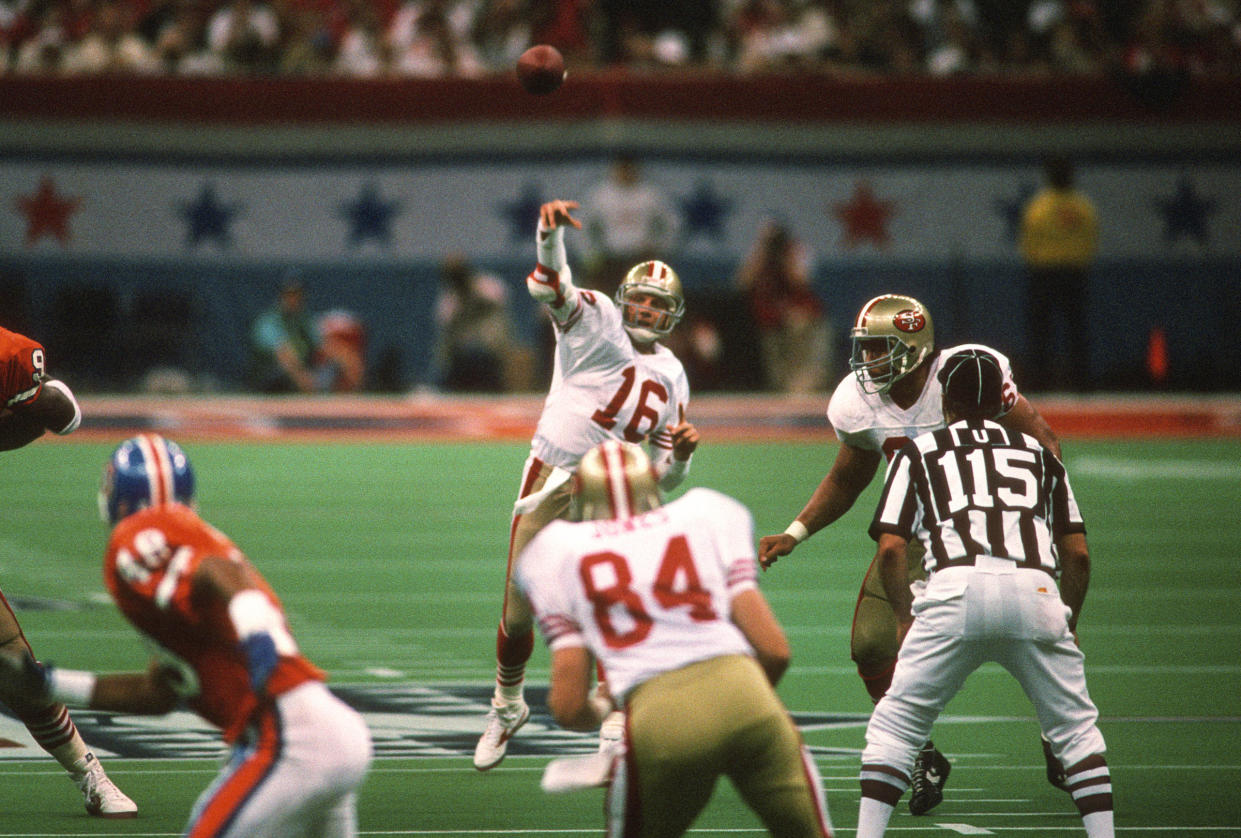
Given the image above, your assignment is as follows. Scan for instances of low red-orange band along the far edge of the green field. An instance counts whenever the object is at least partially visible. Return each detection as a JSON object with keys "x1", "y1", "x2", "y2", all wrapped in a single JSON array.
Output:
[{"x1": 58, "y1": 394, "x2": 1241, "y2": 444}]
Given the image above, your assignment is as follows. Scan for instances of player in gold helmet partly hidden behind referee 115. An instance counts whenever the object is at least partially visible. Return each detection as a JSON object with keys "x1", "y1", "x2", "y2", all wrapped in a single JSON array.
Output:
[{"x1": 758, "y1": 294, "x2": 1064, "y2": 814}]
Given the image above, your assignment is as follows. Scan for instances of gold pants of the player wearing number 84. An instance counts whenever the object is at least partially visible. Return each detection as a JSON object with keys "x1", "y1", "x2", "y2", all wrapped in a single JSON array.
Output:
[{"x1": 607, "y1": 656, "x2": 831, "y2": 838}]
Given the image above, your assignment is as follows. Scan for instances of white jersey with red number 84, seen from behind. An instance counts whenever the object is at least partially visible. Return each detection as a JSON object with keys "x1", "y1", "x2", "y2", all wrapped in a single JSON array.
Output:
[{"x1": 517, "y1": 488, "x2": 758, "y2": 704}]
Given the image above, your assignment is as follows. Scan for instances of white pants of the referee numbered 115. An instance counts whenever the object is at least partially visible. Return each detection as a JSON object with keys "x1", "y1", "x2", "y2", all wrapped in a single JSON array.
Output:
[{"x1": 862, "y1": 556, "x2": 1106, "y2": 777}]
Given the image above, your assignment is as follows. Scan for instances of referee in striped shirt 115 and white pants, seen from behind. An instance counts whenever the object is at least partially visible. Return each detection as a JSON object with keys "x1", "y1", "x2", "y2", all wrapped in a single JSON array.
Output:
[{"x1": 858, "y1": 348, "x2": 1114, "y2": 838}]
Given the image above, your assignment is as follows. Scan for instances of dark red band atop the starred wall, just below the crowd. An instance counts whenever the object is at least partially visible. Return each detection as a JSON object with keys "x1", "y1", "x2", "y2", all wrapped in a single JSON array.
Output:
[{"x1": 0, "y1": 70, "x2": 1241, "y2": 125}]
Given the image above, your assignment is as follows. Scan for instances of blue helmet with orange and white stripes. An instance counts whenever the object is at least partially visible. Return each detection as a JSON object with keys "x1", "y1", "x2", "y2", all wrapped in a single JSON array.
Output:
[{"x1": 99, "y1": 433, "x2": 194, "y2": 524}]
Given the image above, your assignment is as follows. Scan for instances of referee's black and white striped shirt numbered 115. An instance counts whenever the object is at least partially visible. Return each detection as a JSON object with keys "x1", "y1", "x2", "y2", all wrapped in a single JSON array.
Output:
[{"x1": 870, "y1": 422, "x2": 1086, "y2": 577}]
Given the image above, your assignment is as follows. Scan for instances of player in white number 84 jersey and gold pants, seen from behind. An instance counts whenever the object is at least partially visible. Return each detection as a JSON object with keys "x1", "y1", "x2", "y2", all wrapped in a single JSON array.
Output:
[{"x1": 516, "y1": 439, "x2": 831, "y2": 838}]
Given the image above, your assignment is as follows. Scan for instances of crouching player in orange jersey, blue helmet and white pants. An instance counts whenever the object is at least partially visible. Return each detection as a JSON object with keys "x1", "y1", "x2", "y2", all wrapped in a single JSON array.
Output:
[{"x1": 0, "y1": 433, "x2": 371, "y2": 838}]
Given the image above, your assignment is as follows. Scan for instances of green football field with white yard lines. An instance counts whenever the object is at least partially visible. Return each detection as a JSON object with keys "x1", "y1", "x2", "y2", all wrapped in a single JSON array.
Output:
[{"x1": 0, "y1": 439, "x2": 1241, "y2": 838}]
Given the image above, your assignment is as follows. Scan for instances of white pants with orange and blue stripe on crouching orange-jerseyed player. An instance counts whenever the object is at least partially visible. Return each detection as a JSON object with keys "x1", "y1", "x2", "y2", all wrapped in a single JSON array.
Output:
[{"x1": 185, "y1": 682, "x2": 371, "y2": 838}]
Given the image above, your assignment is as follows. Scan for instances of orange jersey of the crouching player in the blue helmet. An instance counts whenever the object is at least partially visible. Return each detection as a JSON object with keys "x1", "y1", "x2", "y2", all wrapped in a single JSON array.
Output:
[{"x1": 103, "y1": 504, "x2": 325, "y2": 742}]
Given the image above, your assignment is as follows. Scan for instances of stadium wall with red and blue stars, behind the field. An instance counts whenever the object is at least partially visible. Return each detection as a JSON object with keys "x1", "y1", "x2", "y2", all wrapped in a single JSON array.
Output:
[{"x1": 0, "y1": 73, "x2": 1241, "y2": 390}]
